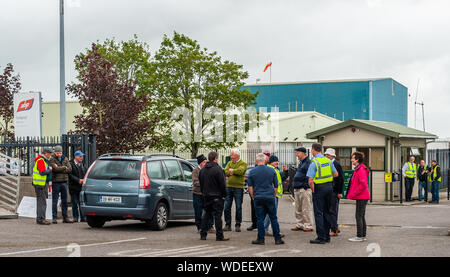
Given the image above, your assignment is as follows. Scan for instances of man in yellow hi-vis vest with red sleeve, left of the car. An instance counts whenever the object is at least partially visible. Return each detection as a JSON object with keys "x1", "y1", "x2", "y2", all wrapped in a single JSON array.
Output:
[{"x1": 33, "y1": 147, "x2": 53, "y2": 225}]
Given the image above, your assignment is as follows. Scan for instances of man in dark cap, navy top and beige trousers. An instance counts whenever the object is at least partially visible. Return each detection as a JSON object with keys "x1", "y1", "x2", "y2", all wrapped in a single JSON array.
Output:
[{"x1": 291, "y1": 147, "x2": 313, "y2": 232}]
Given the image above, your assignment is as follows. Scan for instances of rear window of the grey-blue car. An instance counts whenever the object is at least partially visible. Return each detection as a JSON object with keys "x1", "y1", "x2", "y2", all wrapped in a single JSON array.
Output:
[{"x1": 88, "y1": 159, "x2": 142, "y2": 180}]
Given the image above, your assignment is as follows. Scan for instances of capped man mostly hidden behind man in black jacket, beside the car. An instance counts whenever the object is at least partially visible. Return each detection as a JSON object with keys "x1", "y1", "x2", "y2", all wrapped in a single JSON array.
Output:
[{"x1": 192, "y1": 154, "x2": 215, "y2": 233}]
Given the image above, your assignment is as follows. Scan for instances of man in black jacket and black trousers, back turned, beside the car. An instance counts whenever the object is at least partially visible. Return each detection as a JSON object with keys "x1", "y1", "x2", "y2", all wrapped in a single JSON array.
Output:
[{"x1": 199, "y1": 152, "x2": 229, "y2": 241}]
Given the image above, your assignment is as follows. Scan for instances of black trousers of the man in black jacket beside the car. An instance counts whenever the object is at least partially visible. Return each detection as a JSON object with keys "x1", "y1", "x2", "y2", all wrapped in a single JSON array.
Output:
[{"x1": 200, "y1": 197, "x2": 224, "y2": 239}]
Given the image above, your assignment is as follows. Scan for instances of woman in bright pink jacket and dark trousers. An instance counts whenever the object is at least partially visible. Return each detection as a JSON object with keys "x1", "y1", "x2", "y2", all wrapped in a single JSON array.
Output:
[{"x1": 347, "y1": 152, "x2": 370, "y2": 241}]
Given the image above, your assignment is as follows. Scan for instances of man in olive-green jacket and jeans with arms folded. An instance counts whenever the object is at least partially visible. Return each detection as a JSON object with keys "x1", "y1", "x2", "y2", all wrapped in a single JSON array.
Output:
[{"x1": 223, "y1": 149, "x2": 247, "y2": 232}]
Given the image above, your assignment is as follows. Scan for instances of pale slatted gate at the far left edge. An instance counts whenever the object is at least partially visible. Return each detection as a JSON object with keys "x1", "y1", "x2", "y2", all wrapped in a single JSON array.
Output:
[{"x1": 0, "y1": 153, "x2": 21, "y2": 218}]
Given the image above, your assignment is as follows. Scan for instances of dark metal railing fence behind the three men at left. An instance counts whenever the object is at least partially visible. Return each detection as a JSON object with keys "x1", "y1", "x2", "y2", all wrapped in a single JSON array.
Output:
[{"x1": 0, "y1": 135, "x2": 97, "y2": 176}]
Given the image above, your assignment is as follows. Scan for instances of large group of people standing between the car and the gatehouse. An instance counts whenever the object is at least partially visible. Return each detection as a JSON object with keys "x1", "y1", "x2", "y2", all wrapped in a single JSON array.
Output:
[{"x1": 192, "y1": 143, "x2": 370, "y2": 244}]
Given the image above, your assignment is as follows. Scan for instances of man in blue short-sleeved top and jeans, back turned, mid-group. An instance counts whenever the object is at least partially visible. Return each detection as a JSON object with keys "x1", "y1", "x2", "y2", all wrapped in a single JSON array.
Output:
[{"x1": 248, "y1": 153, "x2": 284, "y2": 244}]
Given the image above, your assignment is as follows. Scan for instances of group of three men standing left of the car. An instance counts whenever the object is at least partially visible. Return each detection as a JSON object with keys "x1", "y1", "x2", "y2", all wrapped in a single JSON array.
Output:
[{"x1": 32, "y1": 146, "x2": 86, "y2": 225}]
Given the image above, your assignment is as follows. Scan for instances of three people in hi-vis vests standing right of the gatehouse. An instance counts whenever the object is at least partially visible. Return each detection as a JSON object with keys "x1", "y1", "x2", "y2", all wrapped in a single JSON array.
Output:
[{"x1": 402, "y1": 156, "x2": 441, "y2": 204}]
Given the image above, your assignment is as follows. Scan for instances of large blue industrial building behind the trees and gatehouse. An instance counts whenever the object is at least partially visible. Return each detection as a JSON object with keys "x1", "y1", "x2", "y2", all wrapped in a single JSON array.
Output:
[{"x1": 243, "y1": 78, "x2": 408, "y2": 126}]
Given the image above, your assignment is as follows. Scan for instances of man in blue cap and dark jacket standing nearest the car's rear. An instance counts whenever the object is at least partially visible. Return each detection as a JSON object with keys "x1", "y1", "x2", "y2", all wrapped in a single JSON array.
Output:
[{"x1": 69, "y1": 151, "x2": 86, "y2": 222}]
